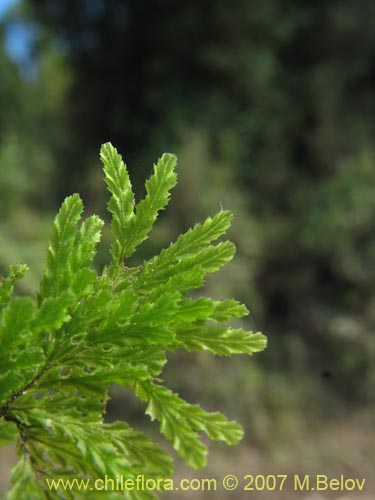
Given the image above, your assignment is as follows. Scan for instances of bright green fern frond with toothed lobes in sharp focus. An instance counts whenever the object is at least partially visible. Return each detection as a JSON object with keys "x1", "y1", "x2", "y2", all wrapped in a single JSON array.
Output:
[{"x1": 0, "y1": 143, "x2": 266, "y2": 500}]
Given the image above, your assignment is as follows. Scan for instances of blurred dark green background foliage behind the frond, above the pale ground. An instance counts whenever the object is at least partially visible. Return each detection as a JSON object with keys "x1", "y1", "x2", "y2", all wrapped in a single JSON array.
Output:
[{"x1": 0, "y1": 0, "x2": 375, "y2": 488}]
